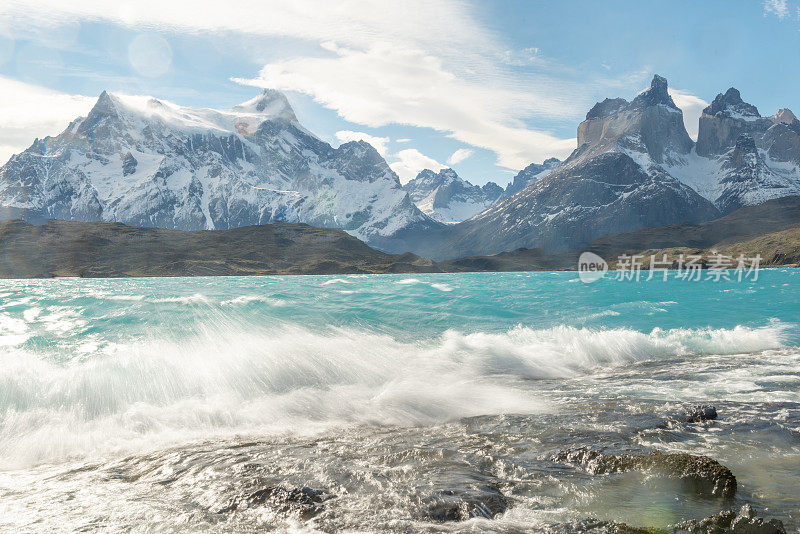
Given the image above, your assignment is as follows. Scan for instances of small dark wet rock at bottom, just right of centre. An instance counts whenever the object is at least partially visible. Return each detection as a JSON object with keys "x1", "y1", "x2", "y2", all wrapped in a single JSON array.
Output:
[{"x1": 428, "y1": 485, "x2": 508, "y2": 522}]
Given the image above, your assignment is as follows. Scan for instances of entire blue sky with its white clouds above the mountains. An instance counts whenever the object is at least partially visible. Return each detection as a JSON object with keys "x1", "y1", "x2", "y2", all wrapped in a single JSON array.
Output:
[{"x1": 0, "y1": 0, "x2": 800, "y2": 185}]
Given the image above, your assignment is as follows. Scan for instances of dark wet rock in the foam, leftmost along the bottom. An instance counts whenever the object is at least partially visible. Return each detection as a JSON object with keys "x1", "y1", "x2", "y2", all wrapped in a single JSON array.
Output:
[{"x1": 217, "y1": 486, "x2": 330, "y2": 521}]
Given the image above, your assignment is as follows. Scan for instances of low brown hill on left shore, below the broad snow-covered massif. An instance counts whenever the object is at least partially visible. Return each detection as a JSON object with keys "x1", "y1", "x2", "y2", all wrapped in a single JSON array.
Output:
[{"x1": 0, "y1": 220, "x2": 436, "y2": 278}]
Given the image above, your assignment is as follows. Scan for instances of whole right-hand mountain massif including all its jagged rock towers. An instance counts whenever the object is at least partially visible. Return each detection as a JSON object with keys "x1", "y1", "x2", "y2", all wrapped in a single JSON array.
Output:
[{"x1": 404, "y1": 76, "x2": 800, "y2": 259}]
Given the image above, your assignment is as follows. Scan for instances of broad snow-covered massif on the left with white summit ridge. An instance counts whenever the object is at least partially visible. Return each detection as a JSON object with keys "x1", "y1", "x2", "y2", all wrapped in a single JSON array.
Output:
[{"x1": 0, "y1": 90, "x2": 439, "y2": 247}]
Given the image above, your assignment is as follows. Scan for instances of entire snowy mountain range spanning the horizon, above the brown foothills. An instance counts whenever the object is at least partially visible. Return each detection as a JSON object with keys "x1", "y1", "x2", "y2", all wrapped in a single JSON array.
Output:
[{"x1": 0, "y1": 76, "x2": 800, "y2": 260}]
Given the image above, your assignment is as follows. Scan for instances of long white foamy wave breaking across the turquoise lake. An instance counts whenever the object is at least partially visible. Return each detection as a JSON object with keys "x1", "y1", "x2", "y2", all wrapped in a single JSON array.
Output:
[{"x1": 0, "y1": 323, "x2": 785, "y2": 467}]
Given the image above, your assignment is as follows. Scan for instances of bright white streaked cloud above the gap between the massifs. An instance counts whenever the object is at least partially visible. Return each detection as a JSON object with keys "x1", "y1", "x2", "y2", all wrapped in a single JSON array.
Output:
[{"x1": 237, "y1": 46, "x2": 575, "y2": 169}]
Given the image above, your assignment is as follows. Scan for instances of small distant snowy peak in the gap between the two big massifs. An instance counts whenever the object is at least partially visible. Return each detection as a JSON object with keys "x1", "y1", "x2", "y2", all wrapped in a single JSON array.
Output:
[{"x1": 403, "y1": 169, "x2": 503, "y2": 223}]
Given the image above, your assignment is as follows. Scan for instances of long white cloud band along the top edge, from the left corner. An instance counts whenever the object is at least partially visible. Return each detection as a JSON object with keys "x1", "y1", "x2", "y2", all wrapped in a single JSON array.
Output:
[{"x1": 0, "y1": 0, "x2": 496, "y2": 59}]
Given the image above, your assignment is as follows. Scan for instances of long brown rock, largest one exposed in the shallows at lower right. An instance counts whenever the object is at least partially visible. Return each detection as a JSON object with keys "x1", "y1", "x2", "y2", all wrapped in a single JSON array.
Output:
[{"x1": 553, "y1": 447, "x2": 736, "y2": 498}]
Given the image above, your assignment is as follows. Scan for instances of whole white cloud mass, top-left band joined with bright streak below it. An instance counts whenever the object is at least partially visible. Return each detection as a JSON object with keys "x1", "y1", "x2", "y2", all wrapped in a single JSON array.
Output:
[{"x1": 0, "y1": 0, "x2": 588, "y2": 169}]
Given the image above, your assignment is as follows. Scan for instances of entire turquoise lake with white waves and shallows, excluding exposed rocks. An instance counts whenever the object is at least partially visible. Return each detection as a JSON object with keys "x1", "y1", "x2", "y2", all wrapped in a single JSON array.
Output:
[{"x1": 0, "y1": 269, "x2": 800, "y2": 532}]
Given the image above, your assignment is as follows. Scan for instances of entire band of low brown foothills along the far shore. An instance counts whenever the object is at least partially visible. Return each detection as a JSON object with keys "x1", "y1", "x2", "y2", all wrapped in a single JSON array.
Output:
[{"x1": 0, "y1": 197, "x2": 800, "y2": 278}]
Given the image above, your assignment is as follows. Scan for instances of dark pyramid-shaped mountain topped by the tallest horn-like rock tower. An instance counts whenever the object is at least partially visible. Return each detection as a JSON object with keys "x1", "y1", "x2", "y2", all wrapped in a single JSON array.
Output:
[{"x1": 406, "y1": 76, "x2": 720, "y2": 258}]
